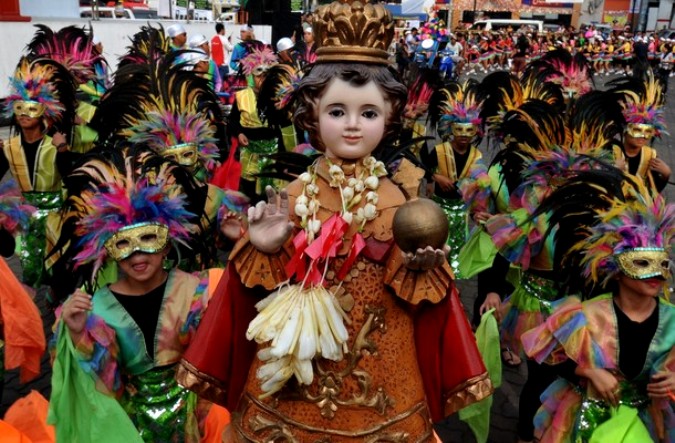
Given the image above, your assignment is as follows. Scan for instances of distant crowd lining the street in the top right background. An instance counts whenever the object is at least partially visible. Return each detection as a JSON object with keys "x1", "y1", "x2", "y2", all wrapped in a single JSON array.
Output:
[{"x1": 393, "y1": 19, "x2": 675, "y2": 85}]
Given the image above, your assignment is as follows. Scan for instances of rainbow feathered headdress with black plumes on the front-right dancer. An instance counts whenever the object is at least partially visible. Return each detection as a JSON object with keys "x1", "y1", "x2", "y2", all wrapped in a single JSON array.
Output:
[{"x1": 537, "y1": 167, "x2": 675, "y2": 297}]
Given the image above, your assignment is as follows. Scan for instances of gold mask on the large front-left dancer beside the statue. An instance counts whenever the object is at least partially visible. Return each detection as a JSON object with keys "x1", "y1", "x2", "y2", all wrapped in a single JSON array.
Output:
[{"x1": 105, "y1": 223, "x2": 169, "y2": 262}]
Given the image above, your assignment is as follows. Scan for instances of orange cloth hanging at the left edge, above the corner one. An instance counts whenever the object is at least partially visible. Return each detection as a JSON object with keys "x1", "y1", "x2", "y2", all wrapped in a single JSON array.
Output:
[{"x1": 0, "y1": 259, "x2": 46, "y2": 383}]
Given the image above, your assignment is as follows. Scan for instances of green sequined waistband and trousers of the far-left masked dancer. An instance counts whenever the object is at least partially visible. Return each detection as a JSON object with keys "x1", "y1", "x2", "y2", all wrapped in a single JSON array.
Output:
[{"x1": 16, "y1": 192, "x2": 63, "y2": 287}]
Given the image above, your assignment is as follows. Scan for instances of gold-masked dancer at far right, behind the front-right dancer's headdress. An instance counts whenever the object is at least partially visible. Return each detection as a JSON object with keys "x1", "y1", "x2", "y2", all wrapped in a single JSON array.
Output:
[{"x1": 610, "y1": 74, "x2": 671, "y2": 192}]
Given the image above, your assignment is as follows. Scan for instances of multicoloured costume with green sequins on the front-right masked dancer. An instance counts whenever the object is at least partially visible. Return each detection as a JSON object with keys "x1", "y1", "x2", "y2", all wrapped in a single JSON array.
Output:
[{"x1": 523, "y1": 294, "x2": 675, "y2": 442}]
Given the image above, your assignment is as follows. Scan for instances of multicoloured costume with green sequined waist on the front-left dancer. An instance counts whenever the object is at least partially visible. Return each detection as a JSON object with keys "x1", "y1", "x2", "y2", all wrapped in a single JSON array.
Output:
[{"x1": 50, "y1": 270, "x2": 227, "y2": 442}]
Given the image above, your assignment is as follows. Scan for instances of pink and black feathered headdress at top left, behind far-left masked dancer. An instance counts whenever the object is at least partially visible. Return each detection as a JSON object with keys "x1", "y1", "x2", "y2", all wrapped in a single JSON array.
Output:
[{"x1": 27, "y1": 25, "x2": 105, "y2": 84}]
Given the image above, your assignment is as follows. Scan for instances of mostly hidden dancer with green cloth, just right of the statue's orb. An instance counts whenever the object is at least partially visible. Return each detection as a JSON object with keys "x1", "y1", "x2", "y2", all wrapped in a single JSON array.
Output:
[{"x1": 459, "y1": 72, "x2": 564, "y2": 340}]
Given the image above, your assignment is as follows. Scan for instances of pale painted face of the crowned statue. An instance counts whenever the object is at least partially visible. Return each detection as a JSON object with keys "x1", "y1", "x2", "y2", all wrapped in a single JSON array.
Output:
[{"x1": 319, "y1": 78, "x2": 391, "y2": 160}]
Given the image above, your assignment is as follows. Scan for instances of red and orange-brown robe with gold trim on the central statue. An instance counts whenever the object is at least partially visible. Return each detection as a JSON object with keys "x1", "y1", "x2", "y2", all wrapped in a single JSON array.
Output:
[{"x1": 178, "y1": 160, "x2": 491, "y2": 442}]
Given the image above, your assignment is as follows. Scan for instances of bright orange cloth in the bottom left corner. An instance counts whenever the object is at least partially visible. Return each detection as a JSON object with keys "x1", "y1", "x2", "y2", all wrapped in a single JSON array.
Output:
[{"x1": 0, "y1": 391, "x2": 56, "y2": 443}]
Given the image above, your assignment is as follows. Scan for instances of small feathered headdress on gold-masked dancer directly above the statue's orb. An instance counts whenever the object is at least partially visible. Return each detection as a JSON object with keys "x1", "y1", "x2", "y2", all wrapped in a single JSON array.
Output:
[{"x1": 437, "y1": 81, "x2": 483, "y2": 137}]
